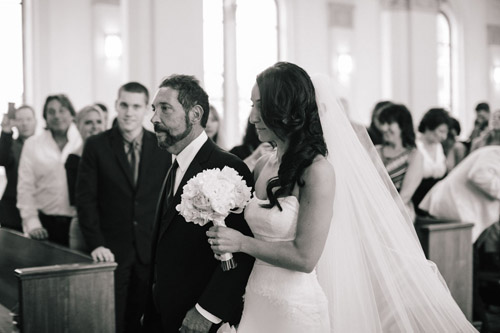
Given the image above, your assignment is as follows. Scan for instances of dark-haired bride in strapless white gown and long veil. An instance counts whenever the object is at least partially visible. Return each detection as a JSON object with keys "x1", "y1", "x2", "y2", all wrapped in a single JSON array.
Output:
[{"x1": 207, "y1": 62, "x2": 476, "y2": 333}]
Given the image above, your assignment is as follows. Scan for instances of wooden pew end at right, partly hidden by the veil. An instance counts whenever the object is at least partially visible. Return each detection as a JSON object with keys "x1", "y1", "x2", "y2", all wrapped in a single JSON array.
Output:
[{"x1": 415, "y1": 217, "x2": 474, "y2": 320}]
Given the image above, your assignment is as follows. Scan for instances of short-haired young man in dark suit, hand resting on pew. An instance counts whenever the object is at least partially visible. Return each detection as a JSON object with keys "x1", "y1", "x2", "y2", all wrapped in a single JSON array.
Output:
[{"x1": 76, "y1": 82, "x2": 171, "y2": 333}]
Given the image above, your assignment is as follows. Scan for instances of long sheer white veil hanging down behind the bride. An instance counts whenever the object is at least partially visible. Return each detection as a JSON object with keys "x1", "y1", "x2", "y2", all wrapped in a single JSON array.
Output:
[{"x1": 312, "y1": 76, "x2": 476, "y2": 333}]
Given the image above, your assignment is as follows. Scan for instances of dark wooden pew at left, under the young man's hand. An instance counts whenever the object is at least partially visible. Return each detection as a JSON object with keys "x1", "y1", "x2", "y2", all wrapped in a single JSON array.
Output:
[{"x1": 0, "y1": 228, "x2": 116, "y2": 333}]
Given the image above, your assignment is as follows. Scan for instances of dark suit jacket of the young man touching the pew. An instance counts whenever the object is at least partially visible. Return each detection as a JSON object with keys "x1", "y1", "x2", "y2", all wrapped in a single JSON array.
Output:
[{"x1": 76, "y1": 128, "x2": 172, "y2": 264}]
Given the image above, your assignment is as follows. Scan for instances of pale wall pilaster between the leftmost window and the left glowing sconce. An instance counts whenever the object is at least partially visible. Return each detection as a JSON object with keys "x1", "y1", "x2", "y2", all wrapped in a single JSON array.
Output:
[{"x1": 23, "y1": 0, "x2": 93, "y2": 120}]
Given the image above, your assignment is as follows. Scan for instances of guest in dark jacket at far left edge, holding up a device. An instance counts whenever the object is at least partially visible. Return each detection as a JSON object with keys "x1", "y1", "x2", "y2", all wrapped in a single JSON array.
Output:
[{"x1": 0, "y1": 105, "x2": 36, "y2": 231}]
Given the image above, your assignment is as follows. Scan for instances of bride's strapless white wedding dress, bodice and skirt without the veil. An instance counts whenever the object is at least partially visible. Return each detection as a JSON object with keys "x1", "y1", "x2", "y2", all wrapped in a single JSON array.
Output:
[{"x1": 238, "y1": 196, "x2": 330, "y2": 333}]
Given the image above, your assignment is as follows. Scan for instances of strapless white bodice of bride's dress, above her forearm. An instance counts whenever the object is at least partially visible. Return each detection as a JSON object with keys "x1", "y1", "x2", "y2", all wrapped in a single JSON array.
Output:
[{"x1": 245, "y1": 195, "x2": 299, "y2": 242}]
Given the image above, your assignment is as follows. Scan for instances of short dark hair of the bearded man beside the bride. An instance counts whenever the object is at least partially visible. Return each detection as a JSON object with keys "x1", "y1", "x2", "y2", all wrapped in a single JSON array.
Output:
[{"x1": 159, "y1": 74, "x2": 210, "y2": 128}]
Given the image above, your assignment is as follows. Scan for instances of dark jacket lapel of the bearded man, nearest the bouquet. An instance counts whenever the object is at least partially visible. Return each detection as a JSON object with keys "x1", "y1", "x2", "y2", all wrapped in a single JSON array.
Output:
[{"x1": 158, "y1": 139, "x2": 215, "y2": 239}]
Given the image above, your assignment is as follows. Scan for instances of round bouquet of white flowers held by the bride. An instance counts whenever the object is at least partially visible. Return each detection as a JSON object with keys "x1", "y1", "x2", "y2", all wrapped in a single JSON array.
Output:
[{"x1": 175, "y1": 166, "x2": 252, "y2": 271}]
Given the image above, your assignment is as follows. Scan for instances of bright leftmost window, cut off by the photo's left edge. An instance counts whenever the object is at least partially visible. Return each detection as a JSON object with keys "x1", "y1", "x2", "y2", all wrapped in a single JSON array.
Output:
[{"x1": 0, "y1": 0, "x2": 24, "y2": 106}]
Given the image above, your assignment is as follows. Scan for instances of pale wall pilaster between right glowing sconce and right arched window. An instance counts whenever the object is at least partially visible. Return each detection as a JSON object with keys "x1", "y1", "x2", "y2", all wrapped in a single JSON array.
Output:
[{"x1": 381, "y1": 0, "x2": 438, "y2": 123}]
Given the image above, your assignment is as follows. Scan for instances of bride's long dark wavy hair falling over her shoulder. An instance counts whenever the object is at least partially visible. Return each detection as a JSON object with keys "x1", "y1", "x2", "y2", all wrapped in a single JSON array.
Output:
[{"x1": 257, "y1": 62, "x2": 327, "y2": 210}]
